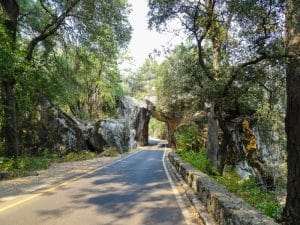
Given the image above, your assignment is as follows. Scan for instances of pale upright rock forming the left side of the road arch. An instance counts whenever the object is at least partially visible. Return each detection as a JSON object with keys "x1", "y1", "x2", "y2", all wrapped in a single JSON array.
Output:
[{"x1": 117, "y1": 97, "x2": 151, "y2": 146}]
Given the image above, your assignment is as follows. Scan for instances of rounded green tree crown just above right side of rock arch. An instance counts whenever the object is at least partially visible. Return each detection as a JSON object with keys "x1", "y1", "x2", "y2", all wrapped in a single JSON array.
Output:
[{"x1": 156, "y1": 45, "x2": 202, "y2": 118}]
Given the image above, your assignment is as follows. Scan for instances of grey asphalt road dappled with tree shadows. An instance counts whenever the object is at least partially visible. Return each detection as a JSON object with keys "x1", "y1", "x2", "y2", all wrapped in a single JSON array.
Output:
[{"x1": 0, "y1": 145, "x2": 186, "y2": 225}]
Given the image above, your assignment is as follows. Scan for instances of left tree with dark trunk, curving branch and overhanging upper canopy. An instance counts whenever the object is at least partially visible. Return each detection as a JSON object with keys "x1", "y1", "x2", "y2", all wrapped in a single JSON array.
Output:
[{"x1": 0, "y1": 0, "x2": 131, "y2": 156}]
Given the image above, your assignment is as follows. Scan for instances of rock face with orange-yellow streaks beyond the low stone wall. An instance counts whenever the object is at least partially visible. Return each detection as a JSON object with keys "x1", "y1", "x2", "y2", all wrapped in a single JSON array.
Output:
[{"x1": 219, "y1": 116, "x2": 282, "y2": 188}]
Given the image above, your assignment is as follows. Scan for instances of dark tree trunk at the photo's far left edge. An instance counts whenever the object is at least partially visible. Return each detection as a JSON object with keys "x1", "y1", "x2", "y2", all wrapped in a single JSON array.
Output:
[{"x1": 0, "y1": 0, "x2": 19, "y2": 156}]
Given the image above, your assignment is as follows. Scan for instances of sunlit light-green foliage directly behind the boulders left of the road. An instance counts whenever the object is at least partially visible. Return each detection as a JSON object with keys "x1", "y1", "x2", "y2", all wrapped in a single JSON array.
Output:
[{"x1": 54, "y1": 48, "x2": 123, "y2": 120}]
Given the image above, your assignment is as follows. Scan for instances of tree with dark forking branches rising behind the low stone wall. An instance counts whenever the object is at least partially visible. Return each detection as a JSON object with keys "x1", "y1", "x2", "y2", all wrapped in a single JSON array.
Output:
[{"x1": 149, "y1": 0, "x2": 283, "y2": 176}]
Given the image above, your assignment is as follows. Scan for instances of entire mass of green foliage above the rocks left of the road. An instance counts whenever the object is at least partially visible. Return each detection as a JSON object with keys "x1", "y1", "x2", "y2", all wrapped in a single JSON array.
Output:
[{"x1": 0, "y1": 0, "x2": 131, "y2": 156}]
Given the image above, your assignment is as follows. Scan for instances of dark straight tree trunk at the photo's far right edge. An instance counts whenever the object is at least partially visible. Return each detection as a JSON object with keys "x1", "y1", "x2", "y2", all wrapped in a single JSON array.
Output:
[{"x1": 284, "y1": 0, "x2": 300, "y2": 225}]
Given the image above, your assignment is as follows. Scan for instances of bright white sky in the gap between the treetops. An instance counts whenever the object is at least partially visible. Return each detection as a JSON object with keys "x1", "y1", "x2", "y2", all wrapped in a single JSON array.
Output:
[{"x1": 121, "y1": 0, "x2": 182, "y2": 73}]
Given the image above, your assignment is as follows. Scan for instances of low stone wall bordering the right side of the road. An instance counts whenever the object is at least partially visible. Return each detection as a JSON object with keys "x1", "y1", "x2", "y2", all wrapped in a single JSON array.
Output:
[{"x1": 168, "y1": 153, "x2": 278, "y2": 225}]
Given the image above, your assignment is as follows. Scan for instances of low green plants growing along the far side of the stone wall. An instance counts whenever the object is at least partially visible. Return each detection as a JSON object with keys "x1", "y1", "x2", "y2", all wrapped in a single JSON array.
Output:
[{"x1": 177, "y1": 126, "x2": 282, "y2": 220}]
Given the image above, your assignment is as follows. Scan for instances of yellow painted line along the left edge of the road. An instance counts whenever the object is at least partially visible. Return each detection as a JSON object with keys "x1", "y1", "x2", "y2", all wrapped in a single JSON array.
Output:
[{"x1": 0, "y1": 150, "x2": 144, "y2": 213}]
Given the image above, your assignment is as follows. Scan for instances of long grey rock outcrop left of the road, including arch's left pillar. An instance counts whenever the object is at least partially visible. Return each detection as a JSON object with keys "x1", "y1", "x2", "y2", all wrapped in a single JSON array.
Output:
[{"x1": 39, "y1": 97, "x2": 150, "y2": 154}]
